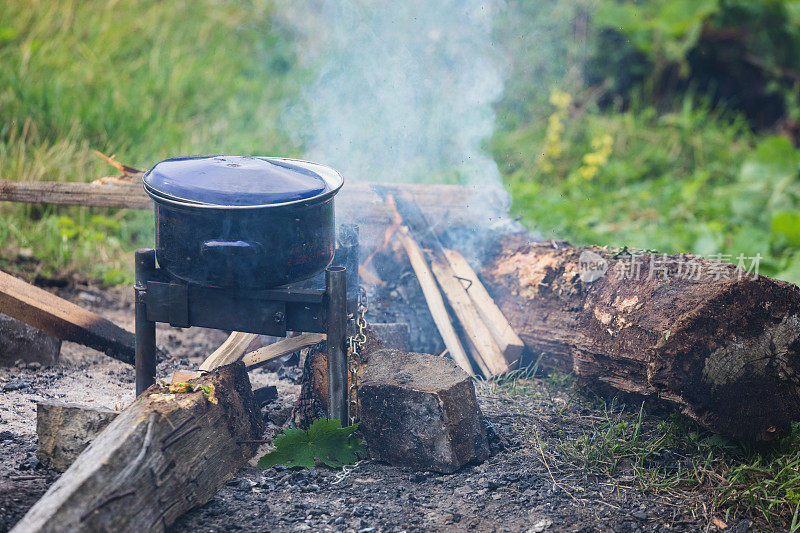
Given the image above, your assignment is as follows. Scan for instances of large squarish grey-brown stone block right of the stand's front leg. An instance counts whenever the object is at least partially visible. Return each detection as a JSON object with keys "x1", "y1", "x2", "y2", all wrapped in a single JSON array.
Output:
[{"x1": 359, "y1": 349, "x2": 489, "y2": 473}]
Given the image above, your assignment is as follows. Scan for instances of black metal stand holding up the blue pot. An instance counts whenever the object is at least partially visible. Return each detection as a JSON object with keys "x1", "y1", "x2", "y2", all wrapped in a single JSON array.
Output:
[{"x1": 134, "y1": 249, "x2": 348, "y2": 425}]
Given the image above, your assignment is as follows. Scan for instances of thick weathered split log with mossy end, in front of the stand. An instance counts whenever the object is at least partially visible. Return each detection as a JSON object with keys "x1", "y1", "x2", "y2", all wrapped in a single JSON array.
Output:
[{"x1": 13, "y1": 363, "x2": 264, "y2": 533}]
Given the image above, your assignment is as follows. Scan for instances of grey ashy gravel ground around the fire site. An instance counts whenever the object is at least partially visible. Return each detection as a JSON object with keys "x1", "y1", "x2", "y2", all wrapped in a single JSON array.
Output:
[{"x1": 0, "y1": 280, "x2": 749, "y2": 533}]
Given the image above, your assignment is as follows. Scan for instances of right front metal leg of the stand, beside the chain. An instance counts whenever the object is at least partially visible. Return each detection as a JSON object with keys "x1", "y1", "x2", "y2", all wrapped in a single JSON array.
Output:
[{"x1": 325, "y1": 266, "x2": 348, "y2": 426}]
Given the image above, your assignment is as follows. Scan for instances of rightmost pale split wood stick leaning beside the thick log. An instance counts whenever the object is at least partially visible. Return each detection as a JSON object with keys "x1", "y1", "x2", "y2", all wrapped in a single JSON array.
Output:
[{"x1": 444, "y1": 249, "x2": 525, "y2": 366}]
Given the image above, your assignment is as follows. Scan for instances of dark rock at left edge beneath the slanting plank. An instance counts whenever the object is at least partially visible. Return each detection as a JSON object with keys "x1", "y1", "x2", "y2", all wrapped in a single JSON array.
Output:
[{"x1": 0, "y1": 313, "x2": 61, "y2": 366}]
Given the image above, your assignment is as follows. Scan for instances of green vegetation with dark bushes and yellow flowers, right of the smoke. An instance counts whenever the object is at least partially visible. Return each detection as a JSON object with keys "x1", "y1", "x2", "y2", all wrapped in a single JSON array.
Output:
[{"x1": 492, "y1": 0, "x2": 800, "y2": 282}]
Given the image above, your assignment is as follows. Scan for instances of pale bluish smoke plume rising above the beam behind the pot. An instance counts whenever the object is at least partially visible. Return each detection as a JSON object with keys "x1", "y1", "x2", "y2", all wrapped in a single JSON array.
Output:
[{"x1": 280, "y1": 0, "x2": 507, "y2": 188}]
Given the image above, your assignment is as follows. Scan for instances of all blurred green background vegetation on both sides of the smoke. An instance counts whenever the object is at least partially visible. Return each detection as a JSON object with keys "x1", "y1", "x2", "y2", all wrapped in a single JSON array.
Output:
[{"x1": 6, "y1": 0, "x2": 800, "y2": 283}]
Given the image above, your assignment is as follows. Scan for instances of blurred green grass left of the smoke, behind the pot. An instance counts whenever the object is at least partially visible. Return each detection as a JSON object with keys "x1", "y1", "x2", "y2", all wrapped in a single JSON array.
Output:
[{"x1": 0, "y1": 0, "x2": 303, "y2": 283}]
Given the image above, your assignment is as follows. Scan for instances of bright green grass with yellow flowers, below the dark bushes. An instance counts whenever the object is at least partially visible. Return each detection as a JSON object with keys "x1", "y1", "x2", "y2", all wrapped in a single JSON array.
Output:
[{"x1": 493, "y1": 93, "x2": 800, "y2": 282}]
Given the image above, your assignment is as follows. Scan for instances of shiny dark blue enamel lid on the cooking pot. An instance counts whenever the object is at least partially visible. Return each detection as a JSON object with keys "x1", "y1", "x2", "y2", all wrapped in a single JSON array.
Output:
[{"x1": 144, "y1": 155, "x2": 332, "y2": 206}]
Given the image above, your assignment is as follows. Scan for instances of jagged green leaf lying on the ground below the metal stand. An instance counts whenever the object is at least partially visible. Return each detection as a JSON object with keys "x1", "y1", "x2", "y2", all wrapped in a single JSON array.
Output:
[{"x1": 258, "y1": 418, "x2": 366, "y2": 468}]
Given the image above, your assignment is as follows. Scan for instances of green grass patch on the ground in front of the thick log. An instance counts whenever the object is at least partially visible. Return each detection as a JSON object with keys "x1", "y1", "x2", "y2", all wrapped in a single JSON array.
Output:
[{"x1": 557, "y1": 406, "x2": 800, "y2": 527}]
